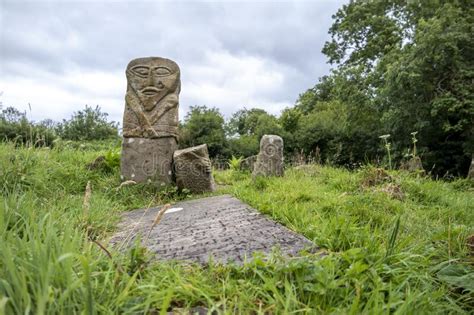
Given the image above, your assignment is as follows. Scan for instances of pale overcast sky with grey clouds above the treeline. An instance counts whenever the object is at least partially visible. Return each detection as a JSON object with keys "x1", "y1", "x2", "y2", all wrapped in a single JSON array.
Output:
[{"x1": 0, "y1": 0, "x2": 343, "y2": 121}]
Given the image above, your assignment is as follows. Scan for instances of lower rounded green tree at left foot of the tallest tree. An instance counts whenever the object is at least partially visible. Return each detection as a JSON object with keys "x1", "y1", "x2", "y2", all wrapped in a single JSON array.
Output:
[{"x1": 288, "y1": 69, "x2": 381, "y2": 166}]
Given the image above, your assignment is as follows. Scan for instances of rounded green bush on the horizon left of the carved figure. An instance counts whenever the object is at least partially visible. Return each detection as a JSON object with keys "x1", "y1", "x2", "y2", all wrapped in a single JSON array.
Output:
[{"x1": 57, "y1": 105, "x2": 118, "y2": 141}]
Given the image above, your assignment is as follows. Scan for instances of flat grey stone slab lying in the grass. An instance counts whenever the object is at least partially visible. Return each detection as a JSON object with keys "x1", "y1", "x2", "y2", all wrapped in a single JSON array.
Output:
[{"x1": 111, "y1": 195, "x2": 315, "y2": 264}]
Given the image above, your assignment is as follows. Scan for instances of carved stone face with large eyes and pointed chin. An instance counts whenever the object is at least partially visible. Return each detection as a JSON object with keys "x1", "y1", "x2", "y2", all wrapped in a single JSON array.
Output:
[{"x1": 126, "y1": 57, "x2": 180, "y2": 111}]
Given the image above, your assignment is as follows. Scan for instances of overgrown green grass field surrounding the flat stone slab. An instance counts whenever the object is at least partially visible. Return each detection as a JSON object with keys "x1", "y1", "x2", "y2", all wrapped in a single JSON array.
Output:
[{"x1": 0, "y1": 143, "x2": 474, "y2": 314}]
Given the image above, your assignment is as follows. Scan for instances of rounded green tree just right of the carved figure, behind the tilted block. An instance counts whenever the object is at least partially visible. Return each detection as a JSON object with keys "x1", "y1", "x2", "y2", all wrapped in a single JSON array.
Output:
[{"x1": 180, "y1": 106, "x2": 227, "y2": 157}]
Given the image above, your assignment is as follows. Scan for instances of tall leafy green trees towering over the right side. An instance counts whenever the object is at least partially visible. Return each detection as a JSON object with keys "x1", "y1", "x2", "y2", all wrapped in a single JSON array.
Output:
[{"x1": 310, "y1": 1, "x2": 474, "y2": 175}]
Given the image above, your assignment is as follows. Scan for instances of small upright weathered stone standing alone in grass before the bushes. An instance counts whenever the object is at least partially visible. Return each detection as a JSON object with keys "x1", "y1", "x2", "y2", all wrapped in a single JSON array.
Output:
[{"x1": 252, "y1": 135, "x2": 284, "y2": 177}]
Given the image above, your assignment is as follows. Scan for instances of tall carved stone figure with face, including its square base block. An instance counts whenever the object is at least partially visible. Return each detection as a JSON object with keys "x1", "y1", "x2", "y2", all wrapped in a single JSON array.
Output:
[{"x1": 121, "y1": 57, "x2": 181, "y2": 185}]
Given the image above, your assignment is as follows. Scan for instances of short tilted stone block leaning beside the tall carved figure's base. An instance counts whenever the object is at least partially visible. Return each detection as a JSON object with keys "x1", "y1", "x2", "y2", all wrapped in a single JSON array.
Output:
[{"x1": 173, "y1": 144, "x2": 215, "y2": 193}]
